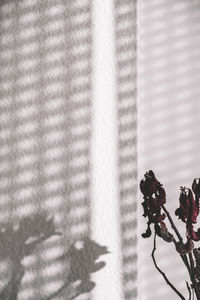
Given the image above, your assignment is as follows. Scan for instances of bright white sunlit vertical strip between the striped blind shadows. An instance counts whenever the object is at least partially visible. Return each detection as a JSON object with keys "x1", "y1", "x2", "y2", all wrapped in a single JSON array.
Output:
[{"x1": 91, "y1": 0, "x2": 122, "y2": 300}]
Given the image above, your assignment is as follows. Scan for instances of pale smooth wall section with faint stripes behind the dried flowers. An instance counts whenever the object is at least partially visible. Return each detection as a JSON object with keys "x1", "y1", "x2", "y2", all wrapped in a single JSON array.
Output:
[{"x1": 138, "y1": 0, "x2": 200, "y2": 300}]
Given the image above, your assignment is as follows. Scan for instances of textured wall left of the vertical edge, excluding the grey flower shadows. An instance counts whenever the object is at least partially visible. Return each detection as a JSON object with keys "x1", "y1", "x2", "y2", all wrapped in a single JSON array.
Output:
[{"x1": 0, "y1": 0, "x2": 137, "y2": 300}]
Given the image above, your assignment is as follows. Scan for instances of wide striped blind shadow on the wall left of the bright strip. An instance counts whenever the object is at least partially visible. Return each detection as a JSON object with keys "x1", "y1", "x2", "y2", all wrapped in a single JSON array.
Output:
[{"x1": 0, "y1": 0, "x2": 91, "y2": 300}]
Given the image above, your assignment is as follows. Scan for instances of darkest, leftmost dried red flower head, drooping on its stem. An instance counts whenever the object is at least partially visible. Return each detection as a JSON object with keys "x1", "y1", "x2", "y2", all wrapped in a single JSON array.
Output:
[{"x1": 140, "y1": 171, "x2": 166, "y2": 237}]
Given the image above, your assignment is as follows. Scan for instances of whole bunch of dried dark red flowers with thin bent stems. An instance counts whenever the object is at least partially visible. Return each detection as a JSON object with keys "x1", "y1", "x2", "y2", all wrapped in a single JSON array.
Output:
[{"x1": 140, "y1": 171, "x2": 200, "y2": 300}]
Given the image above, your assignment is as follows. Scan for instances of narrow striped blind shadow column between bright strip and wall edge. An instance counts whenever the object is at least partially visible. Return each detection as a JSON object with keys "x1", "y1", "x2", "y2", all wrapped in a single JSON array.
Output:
[{"x1": 115, "y1": 0, "x2": 137, "y2": 300}]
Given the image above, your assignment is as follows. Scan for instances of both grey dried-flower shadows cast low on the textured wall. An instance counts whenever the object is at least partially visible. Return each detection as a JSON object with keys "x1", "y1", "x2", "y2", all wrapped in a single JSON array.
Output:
[{"x1": 0, "y1": 213, "x2": 109, "y2": 300}]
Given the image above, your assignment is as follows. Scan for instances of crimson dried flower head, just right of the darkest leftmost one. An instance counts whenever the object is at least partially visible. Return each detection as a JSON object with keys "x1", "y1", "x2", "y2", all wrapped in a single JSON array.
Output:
[{"x1": 175, "y1": 187, "x2": 200, "y2": 241}]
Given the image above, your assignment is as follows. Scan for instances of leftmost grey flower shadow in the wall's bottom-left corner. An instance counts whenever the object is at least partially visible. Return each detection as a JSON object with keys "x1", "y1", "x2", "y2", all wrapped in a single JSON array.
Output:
[{"x1": 0, "y1": 213, "x2": 60, "y2": 300}]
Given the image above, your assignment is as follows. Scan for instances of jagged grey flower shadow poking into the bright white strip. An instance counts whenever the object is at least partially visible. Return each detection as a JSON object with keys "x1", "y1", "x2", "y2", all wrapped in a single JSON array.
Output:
[{"x1": 45, "y1": 237, "x2": 110, "y2": 300}]
